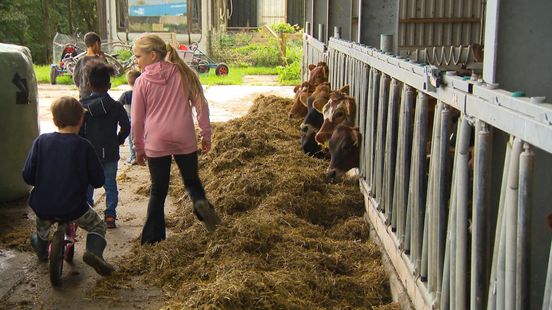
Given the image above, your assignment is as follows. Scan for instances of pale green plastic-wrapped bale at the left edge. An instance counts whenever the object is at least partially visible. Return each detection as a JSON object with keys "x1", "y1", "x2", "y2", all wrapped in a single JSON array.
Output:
[{"x1": 0, "y1": 43, "x2": 39, "y2": 202}]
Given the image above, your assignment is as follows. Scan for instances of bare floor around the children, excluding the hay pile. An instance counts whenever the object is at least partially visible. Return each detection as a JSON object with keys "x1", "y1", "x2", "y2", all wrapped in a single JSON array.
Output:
[{"x1": 0, "y1": 80, "x2": 293, "y2": 309}]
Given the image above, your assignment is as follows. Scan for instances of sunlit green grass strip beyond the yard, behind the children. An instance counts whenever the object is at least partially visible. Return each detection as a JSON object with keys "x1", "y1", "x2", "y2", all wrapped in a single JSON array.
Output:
[{"x1": 34, "y1": 65, "x2": 282, "y2": 87}]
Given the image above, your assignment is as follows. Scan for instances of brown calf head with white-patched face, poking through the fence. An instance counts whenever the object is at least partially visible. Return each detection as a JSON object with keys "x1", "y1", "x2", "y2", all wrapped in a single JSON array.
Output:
[{"x1": 315, "y1": 85, "x2": 356, "y2": 144}]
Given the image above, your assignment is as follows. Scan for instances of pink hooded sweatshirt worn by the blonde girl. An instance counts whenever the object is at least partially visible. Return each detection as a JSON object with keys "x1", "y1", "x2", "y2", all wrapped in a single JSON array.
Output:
[{"x1": 131, "y1": 61, "x2": 211, "y2": 157}]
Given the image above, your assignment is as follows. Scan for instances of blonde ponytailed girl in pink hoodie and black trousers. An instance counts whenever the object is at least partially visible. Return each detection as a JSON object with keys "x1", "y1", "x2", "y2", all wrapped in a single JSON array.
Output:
[{"x1": 131, "y1": 34, "x2": 220, "y2": 244}]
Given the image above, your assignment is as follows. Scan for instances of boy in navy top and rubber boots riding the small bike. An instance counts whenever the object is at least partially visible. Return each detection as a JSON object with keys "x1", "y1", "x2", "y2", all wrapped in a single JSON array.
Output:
[{"x1": 23, "y1": 97, "x2": 113, "y2": 276}]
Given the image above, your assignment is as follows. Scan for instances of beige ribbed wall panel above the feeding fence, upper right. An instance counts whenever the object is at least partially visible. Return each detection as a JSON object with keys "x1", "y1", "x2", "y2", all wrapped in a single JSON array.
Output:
[{"x1": 399, "y1": 0, "x2": 484, "y2": 49}]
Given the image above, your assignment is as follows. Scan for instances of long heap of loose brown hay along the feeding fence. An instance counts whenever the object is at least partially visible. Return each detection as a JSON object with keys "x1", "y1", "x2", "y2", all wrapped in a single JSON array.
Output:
[{"x1": 101, "y1": 96, "x2": 390, "y2": 309}]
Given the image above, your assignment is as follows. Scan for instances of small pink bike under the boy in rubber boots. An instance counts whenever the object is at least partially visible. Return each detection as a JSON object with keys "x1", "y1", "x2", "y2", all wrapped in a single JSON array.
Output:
[{"x1": 48, "y1": 221, "x2": 77, "y2": 286}]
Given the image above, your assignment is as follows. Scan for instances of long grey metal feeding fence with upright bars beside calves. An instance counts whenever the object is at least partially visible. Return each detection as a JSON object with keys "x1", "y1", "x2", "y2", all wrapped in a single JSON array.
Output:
[{"x1": 303, "y1": 34, "x2": 552, "y2": 309}]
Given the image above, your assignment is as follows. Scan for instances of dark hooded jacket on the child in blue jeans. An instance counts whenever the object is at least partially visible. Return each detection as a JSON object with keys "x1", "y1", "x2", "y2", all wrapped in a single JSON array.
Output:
[{"x1": 81, "y1": 93, "x2": 130, "y2": 163}]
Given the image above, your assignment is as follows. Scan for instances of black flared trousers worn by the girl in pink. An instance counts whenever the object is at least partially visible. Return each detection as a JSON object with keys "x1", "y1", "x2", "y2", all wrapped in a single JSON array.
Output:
[{"x1": 142, "y1": 152, "x2": 205, "y2": 244}]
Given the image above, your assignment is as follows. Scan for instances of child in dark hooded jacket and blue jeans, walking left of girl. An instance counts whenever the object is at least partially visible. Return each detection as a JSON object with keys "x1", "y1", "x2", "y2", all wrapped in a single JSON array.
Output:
[{"x1": 81, "y1": 62, "x2": 130, "y2": 228}]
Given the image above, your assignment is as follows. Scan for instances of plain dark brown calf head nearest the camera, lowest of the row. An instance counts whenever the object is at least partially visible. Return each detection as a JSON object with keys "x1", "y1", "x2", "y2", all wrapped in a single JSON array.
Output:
[{"x1": 326, "y1": 125, "x2": 361, "y2": 182}]
